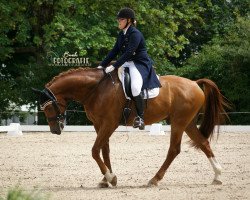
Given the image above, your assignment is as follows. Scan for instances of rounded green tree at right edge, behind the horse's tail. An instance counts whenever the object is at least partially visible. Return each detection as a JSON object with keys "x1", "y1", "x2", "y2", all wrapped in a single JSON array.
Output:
[{"x1": 177, "y1": 17, "x2": 250, "y2": 123}]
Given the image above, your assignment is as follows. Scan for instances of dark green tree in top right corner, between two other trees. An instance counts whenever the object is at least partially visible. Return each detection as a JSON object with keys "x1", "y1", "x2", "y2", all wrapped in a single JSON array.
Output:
[{"x1": 171, "y1": 0, "x2": 250, "y2": 67}]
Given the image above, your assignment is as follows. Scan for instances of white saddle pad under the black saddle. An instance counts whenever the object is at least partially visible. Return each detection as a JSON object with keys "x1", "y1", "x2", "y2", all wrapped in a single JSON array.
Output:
[{"x1": 118, "y1": 66, "x2": 160, "y2": 99}]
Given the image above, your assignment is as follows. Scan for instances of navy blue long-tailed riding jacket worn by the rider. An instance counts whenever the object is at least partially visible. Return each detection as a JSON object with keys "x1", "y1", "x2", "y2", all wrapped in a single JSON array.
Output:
[{"x1": 100, "y1": 26, "x2": 161, "y2": 90}]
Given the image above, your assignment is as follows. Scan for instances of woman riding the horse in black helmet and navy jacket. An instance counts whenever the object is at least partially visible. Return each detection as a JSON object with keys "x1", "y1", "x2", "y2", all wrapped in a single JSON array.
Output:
[{"x1": 98, "y1": 7, "x2": 161, "y2": 130}]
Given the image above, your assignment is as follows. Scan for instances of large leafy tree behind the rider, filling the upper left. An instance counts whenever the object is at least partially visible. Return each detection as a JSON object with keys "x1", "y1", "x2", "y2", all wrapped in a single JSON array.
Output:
[{"x1": 0, "y1": 0, "x2": 201, "y2": 122}]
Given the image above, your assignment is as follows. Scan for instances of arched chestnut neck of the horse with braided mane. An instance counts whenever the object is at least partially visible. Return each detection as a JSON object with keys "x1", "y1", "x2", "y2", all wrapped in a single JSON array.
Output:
[{"x1": 49, "y1": 70, "x2": 103, "y2": 102}]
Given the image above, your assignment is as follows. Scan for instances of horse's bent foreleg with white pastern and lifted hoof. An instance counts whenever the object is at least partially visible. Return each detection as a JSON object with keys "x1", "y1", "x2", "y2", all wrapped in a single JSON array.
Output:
[{"x1": 92, "y1": 130, "x2": 117, "y2": 186}]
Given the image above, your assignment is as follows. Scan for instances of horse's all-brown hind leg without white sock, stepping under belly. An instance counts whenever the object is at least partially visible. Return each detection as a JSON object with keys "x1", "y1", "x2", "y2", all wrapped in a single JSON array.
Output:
[{"x1": 148, "y1": 127, "x2": 183, "y2": 186}]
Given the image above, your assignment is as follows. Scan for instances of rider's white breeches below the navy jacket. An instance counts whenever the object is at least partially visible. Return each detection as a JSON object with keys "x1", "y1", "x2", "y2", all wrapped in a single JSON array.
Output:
[{"x1": 122, "y1": 61, "x2": 143, "y2": 97}]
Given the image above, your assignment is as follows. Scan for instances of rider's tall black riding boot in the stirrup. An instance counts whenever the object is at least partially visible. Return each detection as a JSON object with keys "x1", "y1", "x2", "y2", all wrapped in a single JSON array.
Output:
[{"x1": 133, "y1": 93, "x2": 145, "y2": 130}]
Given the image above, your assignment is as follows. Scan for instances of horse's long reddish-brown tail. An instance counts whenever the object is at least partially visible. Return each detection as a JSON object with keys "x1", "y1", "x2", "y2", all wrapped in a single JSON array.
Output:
[{"x1": 196, "y1": 78, "x2": 230, "y2": 138}]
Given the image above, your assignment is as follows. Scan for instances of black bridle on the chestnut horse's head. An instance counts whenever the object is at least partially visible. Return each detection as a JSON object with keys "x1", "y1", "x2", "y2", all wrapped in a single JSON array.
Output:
[{"x1": 40, "y1": 88, "x2": 66, "y2": 129}]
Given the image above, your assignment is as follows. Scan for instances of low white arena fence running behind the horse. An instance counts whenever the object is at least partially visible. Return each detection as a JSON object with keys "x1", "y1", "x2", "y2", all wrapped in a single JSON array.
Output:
[{"x1": 0, "y1": 110, "x2": 250, "y2": 135}]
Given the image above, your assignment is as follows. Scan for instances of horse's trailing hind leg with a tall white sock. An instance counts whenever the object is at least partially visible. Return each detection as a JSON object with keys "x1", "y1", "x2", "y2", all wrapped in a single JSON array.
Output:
[{"x1": 185, "y1": 121, "x2": 222, "y2": 184}]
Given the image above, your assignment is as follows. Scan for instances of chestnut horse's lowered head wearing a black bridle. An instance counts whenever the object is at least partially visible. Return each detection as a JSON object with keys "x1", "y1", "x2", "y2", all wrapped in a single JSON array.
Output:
[{"x1": 32, "y1": 88, "x2": 66, "y2": 135}]
